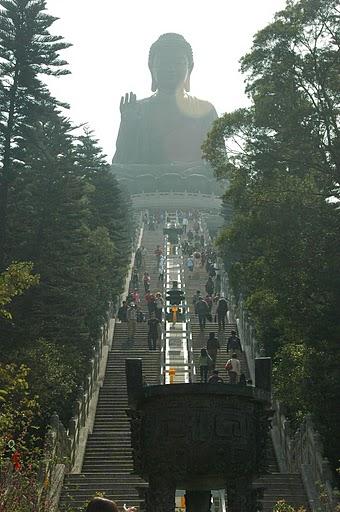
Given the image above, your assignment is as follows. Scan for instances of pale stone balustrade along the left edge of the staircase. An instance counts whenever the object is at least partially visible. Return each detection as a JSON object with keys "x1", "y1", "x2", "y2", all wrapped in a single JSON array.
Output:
[{"x1": 39, "y1": 212, "x2": 143, "y2": 512}]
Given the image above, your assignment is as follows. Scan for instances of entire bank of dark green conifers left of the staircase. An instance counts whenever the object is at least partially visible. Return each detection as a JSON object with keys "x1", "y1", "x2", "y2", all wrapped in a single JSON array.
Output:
[{"x1": 0, "y1": 0, "x2": 132, "y2": 478}]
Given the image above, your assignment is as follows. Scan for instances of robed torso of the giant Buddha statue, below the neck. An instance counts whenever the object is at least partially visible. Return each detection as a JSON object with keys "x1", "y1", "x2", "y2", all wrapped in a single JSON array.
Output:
[{"x1": 113, "y1": 93, "x2": 217, "y2": 165}]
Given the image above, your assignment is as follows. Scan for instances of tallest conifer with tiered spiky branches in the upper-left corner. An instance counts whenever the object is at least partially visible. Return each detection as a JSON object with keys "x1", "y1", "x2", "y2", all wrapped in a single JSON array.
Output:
[{"x1": 0, "y1": 0, "x2": 70, "y2": 269}]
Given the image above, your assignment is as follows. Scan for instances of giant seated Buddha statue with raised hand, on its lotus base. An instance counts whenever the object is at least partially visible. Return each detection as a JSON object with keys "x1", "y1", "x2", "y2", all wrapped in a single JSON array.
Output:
[{"x1": 112, "y1": 33, "x2": 217, "y2": 193}]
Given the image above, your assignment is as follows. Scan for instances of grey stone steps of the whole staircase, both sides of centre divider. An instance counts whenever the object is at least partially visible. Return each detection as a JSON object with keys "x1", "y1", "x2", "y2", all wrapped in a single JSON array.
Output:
[{"x1": 59, "y1": 225, "x2": 308, "y2": 512}]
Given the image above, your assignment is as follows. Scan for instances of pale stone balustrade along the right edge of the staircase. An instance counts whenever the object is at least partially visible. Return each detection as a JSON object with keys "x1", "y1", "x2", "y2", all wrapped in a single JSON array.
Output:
[{"x1": 219, "y1": 259, "x2": 340, "y2": 512}]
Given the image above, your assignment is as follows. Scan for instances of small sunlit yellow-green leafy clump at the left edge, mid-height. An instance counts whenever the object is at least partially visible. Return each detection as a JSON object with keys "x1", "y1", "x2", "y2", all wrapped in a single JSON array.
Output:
[{"x1": 0, "y1": 262, "x2": 39, "y2": 319}]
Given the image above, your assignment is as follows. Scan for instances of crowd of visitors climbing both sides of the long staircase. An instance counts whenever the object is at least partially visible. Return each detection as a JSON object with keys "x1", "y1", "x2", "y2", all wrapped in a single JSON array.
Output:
[{"x1": 118, "y1": 211, "x2": 245, "y2": 384}]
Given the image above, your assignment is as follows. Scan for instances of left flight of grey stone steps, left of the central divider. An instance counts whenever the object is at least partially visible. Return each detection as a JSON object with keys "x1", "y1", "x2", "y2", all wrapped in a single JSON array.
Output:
[{"x1": 59, "y1": 231, "x2": 163, "y2": 512}]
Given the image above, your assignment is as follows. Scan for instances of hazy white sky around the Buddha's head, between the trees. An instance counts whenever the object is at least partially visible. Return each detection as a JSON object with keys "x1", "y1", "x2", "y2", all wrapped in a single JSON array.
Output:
[{"x1": 47, "y1": 0, "x2": 286, "y2": 160}]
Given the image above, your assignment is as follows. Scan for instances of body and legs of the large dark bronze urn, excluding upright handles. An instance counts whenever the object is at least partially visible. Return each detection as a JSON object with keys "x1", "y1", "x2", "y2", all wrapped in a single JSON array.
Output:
[{"x1": 128, "y1": 364, "x2": 271, "y2": 512}]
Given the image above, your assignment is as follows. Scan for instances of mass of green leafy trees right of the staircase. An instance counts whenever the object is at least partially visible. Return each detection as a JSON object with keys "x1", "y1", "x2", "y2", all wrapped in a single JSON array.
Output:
[{"x1": 204, "y1": 0, "x2": 340, "y2": 474}]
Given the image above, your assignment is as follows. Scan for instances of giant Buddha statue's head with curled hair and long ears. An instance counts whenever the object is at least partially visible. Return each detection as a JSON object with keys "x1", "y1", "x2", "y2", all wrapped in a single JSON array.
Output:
[{"x1": 149, "y1": 33, "x2": 194, "y2": 93}]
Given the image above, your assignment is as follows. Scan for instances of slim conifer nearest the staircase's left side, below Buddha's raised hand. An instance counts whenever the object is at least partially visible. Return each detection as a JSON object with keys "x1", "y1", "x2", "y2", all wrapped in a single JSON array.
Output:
[{"x1": 76, "y1": 129, "x2": 132, "y2": 330}]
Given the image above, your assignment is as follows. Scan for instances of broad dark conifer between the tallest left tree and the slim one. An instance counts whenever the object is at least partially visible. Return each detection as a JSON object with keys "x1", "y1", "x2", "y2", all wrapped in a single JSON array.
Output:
[{"x1": 8, "y1": 111, "x2": 91, "y2": 352}]
